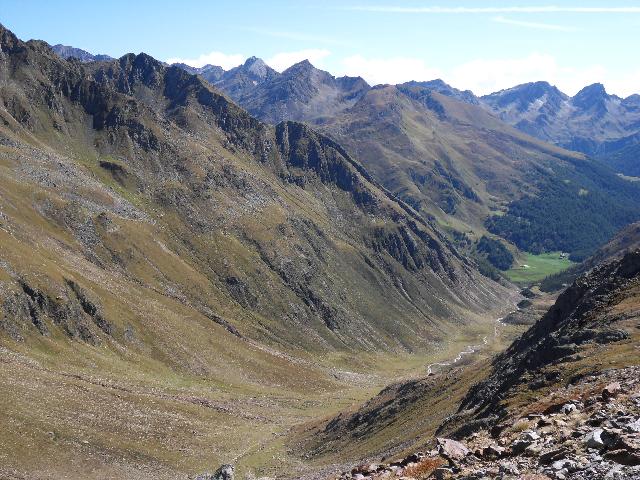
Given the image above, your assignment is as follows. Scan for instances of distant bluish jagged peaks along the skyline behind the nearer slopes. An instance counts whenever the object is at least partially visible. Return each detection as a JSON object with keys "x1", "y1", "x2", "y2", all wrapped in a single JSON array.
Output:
[{"x1": 54, "y1": 45, "x2": 640, "y2": 180}]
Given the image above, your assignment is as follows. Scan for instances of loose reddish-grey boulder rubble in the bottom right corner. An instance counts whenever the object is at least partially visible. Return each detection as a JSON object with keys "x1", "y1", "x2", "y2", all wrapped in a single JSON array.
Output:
[{"x1": 339, "y1": 367, "x2": 640, "y2": 480}]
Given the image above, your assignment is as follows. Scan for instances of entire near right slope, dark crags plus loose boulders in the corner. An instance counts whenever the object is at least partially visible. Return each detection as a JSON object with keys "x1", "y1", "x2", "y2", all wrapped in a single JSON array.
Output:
[{"x1": 330, "y1": 251, "x2": 640, "y2": 480}]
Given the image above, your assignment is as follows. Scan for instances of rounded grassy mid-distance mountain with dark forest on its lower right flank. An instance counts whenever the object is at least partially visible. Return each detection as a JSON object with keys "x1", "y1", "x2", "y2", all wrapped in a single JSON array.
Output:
[{"x1": 320, "y1": 84, "x2": 640, "y2": 258}]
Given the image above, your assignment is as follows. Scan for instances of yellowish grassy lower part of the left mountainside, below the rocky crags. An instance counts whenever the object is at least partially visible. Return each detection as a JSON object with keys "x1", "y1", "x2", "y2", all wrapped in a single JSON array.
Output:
[{"x1": 0, "y1": 136, "x2": 508, "y2": 478}]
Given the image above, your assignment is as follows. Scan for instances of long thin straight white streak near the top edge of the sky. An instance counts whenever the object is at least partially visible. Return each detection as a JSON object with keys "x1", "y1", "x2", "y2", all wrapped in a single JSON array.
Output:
[{"x1": 343, "y1": 5, "x2": 640, "y2": 14}]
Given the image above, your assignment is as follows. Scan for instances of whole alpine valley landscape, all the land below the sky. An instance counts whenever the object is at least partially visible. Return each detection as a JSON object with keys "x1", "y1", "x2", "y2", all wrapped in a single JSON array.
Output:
[{"x1": 0, "y1": 20, "x2": 640, "y2": 480}]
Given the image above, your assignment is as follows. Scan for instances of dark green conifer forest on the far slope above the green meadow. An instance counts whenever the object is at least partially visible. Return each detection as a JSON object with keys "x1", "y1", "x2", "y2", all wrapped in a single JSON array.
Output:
[{"x1": 487, "y1": 156, "x2": 640, "y2": 261}]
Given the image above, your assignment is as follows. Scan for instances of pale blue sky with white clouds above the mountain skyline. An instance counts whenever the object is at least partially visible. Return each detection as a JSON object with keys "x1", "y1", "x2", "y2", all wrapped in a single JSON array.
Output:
[{"x1": 0, "y1": 0, "x2": 640, "y2": 97}]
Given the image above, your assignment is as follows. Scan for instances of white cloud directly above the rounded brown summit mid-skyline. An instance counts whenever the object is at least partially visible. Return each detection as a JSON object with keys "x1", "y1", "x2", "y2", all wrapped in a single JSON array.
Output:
[{"x1": 342, "y1": 55, "x2": 441, "y2": 85}]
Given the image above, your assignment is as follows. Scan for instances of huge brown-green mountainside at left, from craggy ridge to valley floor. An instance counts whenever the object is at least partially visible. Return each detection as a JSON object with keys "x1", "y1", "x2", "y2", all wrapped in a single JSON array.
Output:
[{"x1": 0, "y1": 27, "x2": 513, "y2": 478}]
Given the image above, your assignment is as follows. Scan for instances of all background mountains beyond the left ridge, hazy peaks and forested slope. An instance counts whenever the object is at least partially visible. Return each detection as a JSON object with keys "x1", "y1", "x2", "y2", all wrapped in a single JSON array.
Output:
[{"x1": 160, "y1": 57, "x2": 640, "y2": 260}]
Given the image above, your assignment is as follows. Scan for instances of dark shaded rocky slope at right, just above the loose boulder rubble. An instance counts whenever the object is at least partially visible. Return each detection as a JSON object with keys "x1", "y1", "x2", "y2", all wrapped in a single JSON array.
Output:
[{"x1": 461, "y1": 251, "x2": 640, "y2": 417}]
